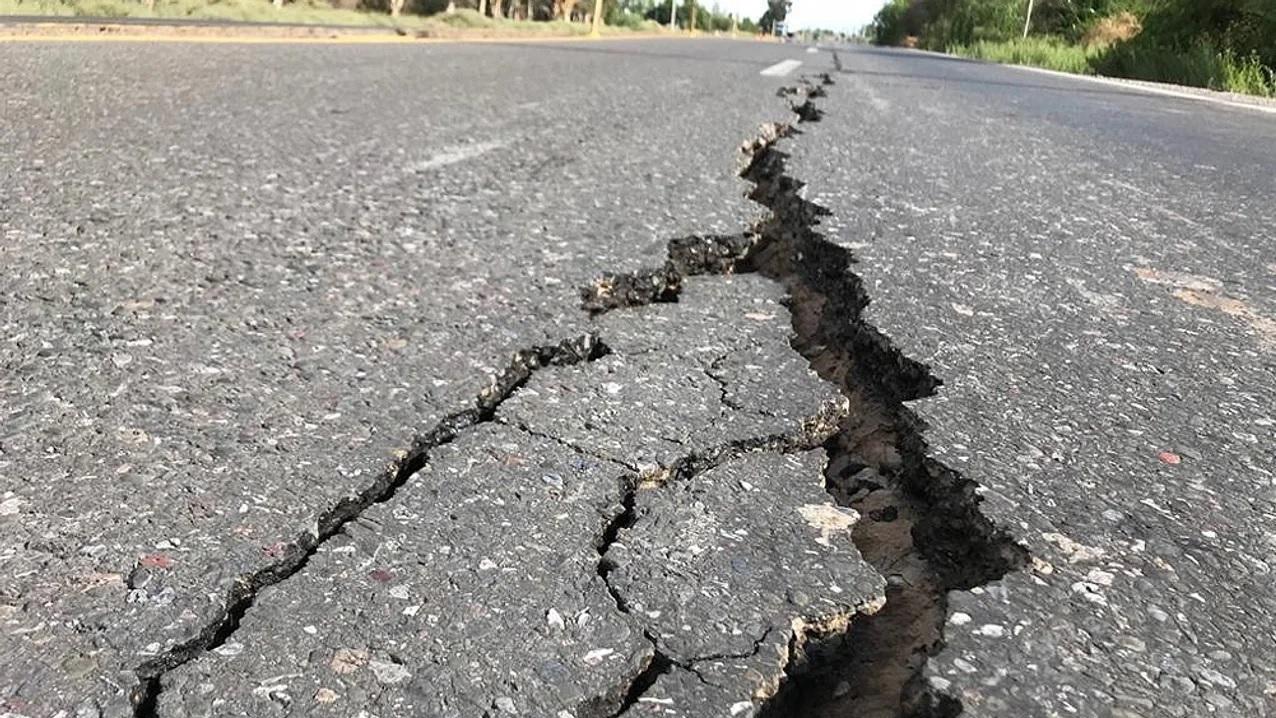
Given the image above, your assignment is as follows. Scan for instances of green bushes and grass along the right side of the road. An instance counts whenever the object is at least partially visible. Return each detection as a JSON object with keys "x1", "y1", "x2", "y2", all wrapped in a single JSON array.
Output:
[{"x1": 869, "y1": 0, "x2": 1276, "y2": 97}]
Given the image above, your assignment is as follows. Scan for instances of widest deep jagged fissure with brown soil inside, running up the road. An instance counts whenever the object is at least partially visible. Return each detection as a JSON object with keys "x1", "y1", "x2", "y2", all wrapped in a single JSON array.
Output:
[{"x1": 582, "y1": 75, "x2": 1027, "y2": 718}]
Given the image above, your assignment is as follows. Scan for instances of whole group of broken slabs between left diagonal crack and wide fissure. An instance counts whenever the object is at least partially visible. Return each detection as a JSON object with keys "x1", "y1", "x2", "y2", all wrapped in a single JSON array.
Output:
[{"x1": 151, "y1": 267, "x2": 882, "y2": 718}]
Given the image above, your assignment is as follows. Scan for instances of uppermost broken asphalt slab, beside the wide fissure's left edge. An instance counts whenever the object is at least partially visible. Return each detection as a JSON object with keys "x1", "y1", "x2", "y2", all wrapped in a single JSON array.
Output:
[{"x1": 498, "y1": 275, "x2": 847, "y2": 478}]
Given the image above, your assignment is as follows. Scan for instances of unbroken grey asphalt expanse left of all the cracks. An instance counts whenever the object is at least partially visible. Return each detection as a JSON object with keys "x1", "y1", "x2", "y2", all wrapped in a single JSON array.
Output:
[{"x1": 0, "y1": 41, "x2": 806, "y2": 717}]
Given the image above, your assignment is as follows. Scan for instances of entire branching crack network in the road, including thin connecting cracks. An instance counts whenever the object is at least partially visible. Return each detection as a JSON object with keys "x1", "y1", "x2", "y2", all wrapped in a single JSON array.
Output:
[{"x1": 124, "y1": 56, "x2": 1026, "y2": 718}]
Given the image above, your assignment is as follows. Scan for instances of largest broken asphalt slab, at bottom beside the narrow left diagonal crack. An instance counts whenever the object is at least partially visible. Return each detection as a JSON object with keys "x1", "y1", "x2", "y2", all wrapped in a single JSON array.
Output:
[{"x1": 160, "y1": 423, "x2": 652, "y2": 717}]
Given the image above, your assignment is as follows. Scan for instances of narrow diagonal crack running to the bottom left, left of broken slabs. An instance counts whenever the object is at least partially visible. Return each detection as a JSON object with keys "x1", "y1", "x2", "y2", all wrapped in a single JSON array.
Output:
[{"x1": 131, "y1": 334, "x2": 611, "y2": 718}]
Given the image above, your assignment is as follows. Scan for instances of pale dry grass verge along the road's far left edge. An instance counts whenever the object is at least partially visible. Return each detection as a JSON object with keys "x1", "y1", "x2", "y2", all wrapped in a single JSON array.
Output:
[{"x1": 0, "y1": 0, "x2": 664, "y2": 37}]
